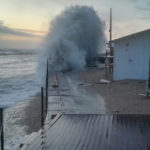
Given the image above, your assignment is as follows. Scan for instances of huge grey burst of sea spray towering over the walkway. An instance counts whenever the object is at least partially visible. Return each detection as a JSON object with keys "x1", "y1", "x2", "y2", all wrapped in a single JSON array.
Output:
[{"x1": 40, "y1": 6, "x2": 106, "y2": 79}]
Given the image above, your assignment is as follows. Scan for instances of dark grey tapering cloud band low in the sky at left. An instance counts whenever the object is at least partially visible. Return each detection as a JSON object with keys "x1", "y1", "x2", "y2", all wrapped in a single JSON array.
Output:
[{"x1": 0, "y1": 21, "x2": 34, "y2": 37}]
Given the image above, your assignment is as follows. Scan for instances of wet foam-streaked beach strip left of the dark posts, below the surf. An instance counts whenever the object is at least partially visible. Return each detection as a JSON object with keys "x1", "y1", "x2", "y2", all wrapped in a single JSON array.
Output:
[{"x1": 4, "y1": 94, "x2": 41, "y2": 150}]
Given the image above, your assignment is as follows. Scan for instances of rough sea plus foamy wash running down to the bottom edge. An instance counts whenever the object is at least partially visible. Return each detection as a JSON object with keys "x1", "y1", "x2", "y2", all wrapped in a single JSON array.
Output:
[{"x1": 0, "y1": 49, "x2": 40, "y2": 150}]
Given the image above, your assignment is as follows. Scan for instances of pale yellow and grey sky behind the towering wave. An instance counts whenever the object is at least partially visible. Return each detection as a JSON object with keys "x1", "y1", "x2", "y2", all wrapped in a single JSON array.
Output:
[{"x1": 0, "y1": 0, "x2": 150, "y2": 48}]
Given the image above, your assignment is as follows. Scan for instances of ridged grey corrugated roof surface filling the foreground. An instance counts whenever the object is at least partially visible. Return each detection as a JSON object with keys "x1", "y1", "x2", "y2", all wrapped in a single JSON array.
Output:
[{"x1": 23, "y1": 115, "x2": 150, "y2": 150}]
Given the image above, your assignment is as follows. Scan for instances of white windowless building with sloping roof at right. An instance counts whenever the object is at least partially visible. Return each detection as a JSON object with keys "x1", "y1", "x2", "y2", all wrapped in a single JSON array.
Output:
[{"x1": 113, "y1": 29, "x2": 150, "y2": 80}]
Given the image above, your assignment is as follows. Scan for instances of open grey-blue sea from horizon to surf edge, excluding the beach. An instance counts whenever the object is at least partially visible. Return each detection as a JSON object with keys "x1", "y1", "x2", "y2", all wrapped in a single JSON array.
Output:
[{"x1": 0, "y1": 49, "x2": 40, "y2": 107}]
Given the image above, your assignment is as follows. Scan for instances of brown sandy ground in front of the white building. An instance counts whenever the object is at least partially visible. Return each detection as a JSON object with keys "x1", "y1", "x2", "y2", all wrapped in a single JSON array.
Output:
[{"x1": 80, "y1": 68, "x2": 150, "y2": 114}]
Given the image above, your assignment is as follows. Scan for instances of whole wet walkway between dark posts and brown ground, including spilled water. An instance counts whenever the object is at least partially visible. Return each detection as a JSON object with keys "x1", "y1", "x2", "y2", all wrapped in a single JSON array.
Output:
[{"x1": 48, "y1": 72, "x2": 106, "y2": 114}]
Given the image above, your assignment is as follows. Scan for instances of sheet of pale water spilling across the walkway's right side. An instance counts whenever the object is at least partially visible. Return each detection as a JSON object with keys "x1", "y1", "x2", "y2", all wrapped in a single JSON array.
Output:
[{"x1": 66, "y1": 75, "x2": 106, "y2": 114}]
